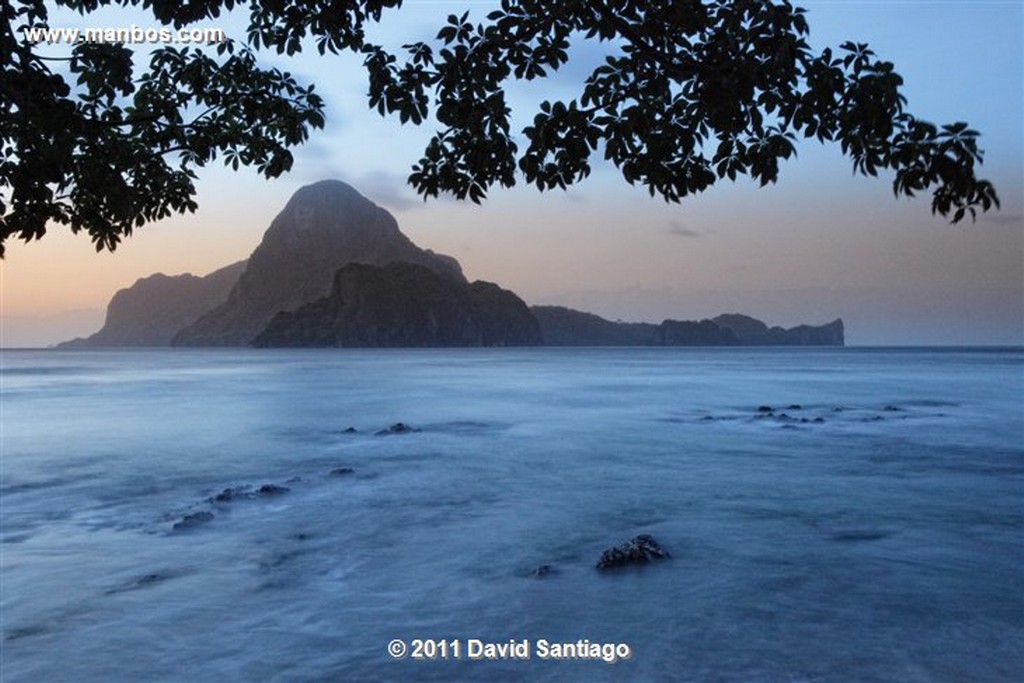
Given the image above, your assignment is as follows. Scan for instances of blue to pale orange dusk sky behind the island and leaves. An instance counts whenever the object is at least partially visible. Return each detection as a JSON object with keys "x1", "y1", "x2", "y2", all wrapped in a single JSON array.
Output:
[{"x1": 0, "y1": 0, "x2": 1024, "y2": 348}]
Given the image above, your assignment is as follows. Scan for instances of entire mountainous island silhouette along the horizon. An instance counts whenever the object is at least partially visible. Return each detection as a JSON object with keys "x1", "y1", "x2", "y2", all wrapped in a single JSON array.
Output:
[{"x1": 60, "y1": 180, "x2": 844, "y2": 347}]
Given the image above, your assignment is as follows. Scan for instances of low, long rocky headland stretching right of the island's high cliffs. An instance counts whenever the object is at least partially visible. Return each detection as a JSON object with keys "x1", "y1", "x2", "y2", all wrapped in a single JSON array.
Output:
[{"x1": 530, "y1": 306, "x2": 845, "y2": 346}]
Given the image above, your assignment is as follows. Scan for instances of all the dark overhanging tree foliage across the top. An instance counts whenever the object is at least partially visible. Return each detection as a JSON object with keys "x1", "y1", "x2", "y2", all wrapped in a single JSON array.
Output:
[{"x1": 0, "y1": 0, "x2": 998, "y2": 255}]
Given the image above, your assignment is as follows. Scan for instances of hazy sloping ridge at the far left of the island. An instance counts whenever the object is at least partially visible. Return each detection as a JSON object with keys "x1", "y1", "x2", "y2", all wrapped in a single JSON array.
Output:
[{"x1": 58, "y1": 261, "x2": 246, "y2": 348}]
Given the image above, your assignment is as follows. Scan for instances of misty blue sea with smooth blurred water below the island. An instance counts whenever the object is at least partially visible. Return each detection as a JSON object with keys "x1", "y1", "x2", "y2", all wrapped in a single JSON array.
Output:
[{"x1": 0, "y1": 347, "x2": 1024, "y2": 683}]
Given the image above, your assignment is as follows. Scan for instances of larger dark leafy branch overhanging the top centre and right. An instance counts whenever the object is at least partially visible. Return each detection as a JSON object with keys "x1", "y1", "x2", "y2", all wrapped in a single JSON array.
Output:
[{"x1": 364, "y1": 0, "x2": 998, "y2": 222}]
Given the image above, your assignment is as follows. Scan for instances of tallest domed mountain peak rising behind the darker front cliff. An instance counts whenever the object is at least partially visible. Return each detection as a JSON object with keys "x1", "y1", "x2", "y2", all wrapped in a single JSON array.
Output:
[{"x1": 173, "y1": 180, "x2": 465, "y2": 346}]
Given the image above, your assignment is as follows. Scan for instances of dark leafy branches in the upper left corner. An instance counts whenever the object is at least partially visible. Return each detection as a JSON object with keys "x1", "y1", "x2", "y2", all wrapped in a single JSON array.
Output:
[{"x1": 0, "y1": 0, "x2": 368, "y2": 256}]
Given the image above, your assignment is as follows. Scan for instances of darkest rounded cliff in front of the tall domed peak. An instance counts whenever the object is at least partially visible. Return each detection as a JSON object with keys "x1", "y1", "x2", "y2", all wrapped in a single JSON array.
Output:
[{"x1": 253, "y1": 263, "x2": 542, "y2": 347}]
